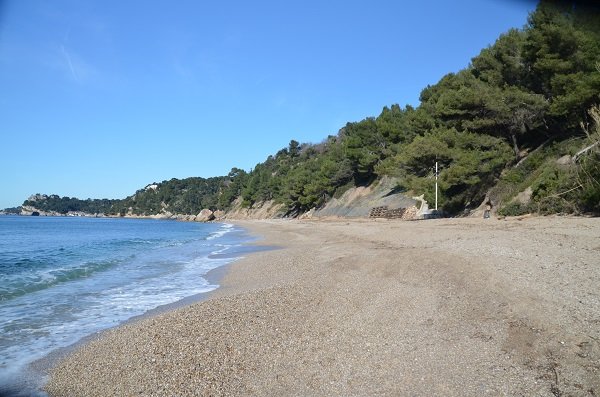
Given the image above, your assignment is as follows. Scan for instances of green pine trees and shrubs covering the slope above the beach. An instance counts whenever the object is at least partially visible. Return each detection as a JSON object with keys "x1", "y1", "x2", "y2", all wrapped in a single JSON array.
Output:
[{"x1": 14, "y1": 1, "x2": 600, "y2": 215}]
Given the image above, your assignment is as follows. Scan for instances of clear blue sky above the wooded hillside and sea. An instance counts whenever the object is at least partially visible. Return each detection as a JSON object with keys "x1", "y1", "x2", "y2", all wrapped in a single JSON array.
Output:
[{"x1": 0, "y1": 0, "x2": 535, "y2": 208}]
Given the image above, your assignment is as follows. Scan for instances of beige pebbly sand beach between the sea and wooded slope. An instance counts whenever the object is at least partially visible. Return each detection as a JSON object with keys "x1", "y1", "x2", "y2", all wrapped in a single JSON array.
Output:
[{"x1": 46, "y1": 217, "x2": 600, "y2": 396}]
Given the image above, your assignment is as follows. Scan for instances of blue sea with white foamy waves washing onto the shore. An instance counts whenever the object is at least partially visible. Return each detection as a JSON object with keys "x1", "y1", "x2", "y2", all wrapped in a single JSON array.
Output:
[{"x1": 0, "y1": 216, "x2": 254, "y2": 396}]
